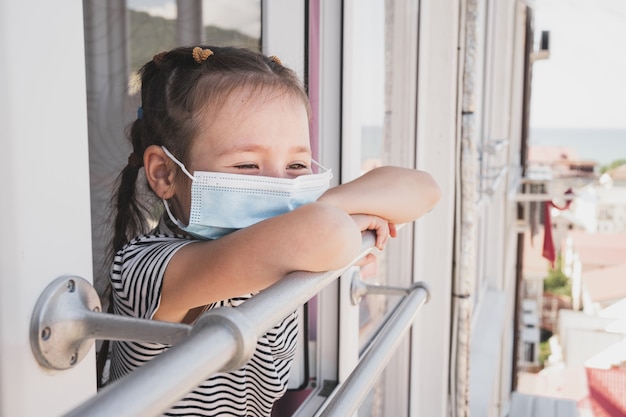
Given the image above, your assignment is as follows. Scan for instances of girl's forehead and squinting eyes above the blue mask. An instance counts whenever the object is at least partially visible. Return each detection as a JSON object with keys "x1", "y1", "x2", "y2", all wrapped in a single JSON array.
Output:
[{"x1": 187, "y1": 90, "x2": 312, "y2": 178}]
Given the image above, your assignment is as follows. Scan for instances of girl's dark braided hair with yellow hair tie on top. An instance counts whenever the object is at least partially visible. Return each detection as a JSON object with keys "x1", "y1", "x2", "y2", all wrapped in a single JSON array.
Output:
[{"x1": 112, "y1": 46, "x2": 309, "y2": 253}]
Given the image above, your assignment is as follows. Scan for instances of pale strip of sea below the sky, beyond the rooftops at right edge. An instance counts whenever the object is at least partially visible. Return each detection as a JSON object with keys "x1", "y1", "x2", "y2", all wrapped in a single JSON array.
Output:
[{"x1": 528, "y1": 127, "x2": 626, "y2": 166}]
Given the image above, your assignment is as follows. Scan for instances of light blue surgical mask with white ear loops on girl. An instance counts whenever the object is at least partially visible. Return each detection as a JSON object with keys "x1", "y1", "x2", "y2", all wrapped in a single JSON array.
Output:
[{"x1": 163, "y1": 147, "x2": 333, "y2": 239}]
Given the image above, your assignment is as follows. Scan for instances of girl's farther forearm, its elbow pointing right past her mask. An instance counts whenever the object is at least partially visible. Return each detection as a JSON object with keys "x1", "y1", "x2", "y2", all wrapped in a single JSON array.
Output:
[{"x1": 318, "y1": 166, "x2": 441, "y2": 224}]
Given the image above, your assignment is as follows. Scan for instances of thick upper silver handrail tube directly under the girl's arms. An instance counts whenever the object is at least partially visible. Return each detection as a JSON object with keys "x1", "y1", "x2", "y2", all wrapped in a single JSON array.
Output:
[{"x1": 65, "y1": 232, "x2": 375, "y2": 417}]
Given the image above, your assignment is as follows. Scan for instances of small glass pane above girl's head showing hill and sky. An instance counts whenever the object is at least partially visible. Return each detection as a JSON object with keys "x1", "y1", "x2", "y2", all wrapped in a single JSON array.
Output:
[{"x1": 202, "y1": 0, "x2": 261, "y2": 52}]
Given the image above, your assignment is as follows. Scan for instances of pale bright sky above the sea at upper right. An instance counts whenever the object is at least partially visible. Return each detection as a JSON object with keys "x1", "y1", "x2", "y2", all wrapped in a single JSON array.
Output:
[{"x1": 530, "y1": 0, "x2": 626, "y2": 129}]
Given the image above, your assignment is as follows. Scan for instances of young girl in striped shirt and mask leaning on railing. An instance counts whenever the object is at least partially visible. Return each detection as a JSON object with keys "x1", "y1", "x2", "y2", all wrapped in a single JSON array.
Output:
[{"x1": 110, "y1": 47, "x2": 439, "y2": 416}]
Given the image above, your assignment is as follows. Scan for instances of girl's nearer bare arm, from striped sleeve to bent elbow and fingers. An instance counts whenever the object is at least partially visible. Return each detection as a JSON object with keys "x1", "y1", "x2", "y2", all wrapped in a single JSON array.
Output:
[{"x1": 153, "y1": 202, "x2": 388, "y2": 322}]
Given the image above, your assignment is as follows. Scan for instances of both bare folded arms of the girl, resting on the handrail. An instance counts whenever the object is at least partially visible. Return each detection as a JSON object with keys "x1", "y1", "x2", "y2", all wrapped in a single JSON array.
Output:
[{"x1": 154, "y1": 167, "x2": 439, "y2": 322}]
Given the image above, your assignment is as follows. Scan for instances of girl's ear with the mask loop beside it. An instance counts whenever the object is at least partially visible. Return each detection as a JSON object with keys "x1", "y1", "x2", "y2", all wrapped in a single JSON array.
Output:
[{"x1": 143, "y1": 145, "x2": 176, "y2": 200}]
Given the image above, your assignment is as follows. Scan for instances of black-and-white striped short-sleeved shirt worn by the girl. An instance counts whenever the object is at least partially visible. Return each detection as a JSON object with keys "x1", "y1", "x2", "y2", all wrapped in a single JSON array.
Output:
[{"x1": 110, "y1": 221, "x2": 298, "y2": 417}]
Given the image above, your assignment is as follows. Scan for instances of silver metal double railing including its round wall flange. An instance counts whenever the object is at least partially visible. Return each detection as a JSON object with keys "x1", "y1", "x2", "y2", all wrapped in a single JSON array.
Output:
[{"x1": 31, "y1": 225, "x2": 429, "y2": 417}]
